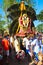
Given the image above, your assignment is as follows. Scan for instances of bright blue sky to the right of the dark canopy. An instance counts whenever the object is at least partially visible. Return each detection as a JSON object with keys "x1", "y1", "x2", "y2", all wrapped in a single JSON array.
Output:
[{"x1": 34, "y1": 0, "x2": 43, "y2": 26}]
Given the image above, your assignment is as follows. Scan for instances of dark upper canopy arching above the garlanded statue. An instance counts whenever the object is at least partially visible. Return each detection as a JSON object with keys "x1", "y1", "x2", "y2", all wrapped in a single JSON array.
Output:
[{"x1": 7, "y1": 4, "x2": 37, "y2": 20}]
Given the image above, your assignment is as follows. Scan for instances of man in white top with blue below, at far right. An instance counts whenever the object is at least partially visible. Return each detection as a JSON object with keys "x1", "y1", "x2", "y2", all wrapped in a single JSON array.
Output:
[{"x1": 31, "y1": 35, "x2": 42, "y2": 62}]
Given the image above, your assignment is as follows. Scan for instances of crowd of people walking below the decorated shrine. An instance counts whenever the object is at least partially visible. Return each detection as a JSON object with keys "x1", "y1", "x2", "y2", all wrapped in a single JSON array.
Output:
[{"x1": 0, "y1": 32, "x2": 43, "y2": 63}]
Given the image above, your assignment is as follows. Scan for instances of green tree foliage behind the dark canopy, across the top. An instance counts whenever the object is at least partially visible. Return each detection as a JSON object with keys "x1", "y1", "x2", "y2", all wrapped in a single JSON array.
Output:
[{"x1": 3, "y1": 0, "x2": 35, "y2": 24}]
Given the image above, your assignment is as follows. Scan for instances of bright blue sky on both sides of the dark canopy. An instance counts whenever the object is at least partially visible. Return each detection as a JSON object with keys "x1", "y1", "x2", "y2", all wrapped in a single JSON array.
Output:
[{"x1": 0, "y1": 0, "x2": 43, "y2": 27}]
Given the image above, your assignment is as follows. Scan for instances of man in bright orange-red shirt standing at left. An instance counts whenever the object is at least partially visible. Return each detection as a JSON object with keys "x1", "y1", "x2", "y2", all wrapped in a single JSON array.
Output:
[{"x1": 2, "y1": 32, "x2": 9, "y2": 63}]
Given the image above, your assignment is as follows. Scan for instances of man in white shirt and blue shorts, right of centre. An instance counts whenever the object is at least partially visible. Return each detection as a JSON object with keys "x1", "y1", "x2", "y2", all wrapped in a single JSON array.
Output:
[{"x1": 23, "y1": 36, "x2": 33, "y2": 63}]
